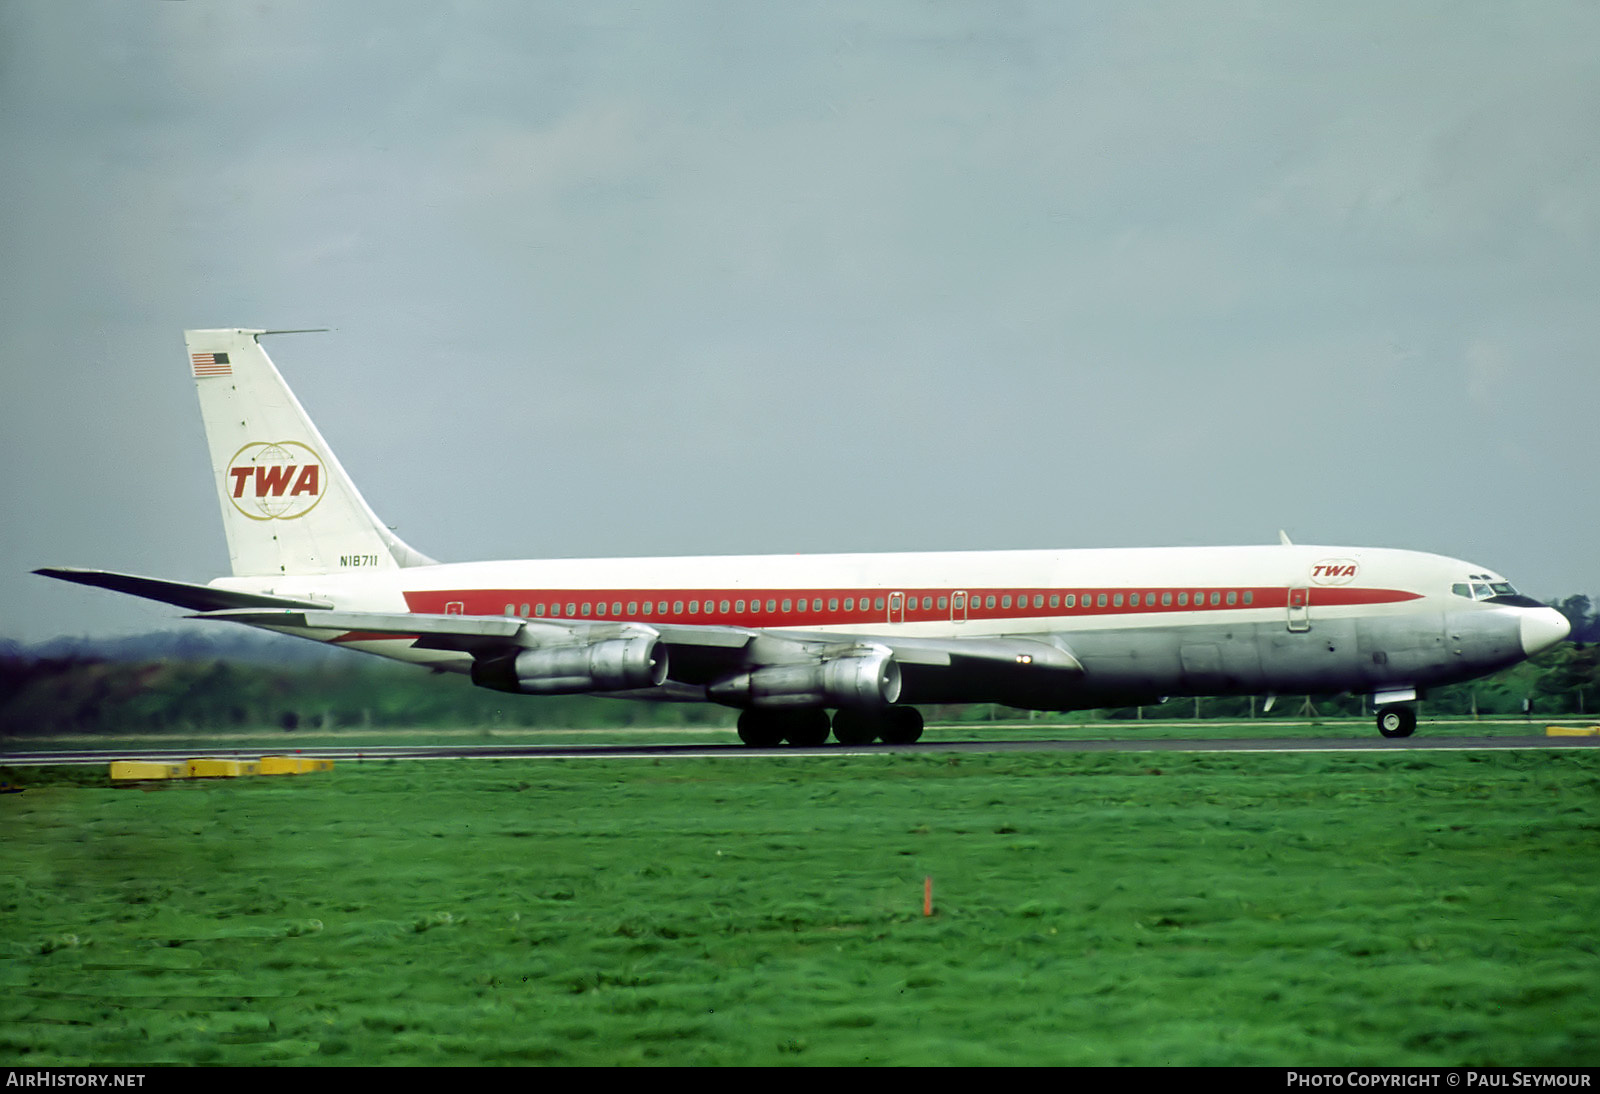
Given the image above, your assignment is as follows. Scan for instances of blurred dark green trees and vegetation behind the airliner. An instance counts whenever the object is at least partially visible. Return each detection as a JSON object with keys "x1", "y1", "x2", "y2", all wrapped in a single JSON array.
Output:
[{"x1": 0, "y1": 597, "x2": 1600, "y2": 736}]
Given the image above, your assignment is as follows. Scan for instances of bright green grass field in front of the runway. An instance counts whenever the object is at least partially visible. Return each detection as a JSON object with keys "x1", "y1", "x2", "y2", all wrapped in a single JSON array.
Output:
[{"x1": 0, "y1": 748, "x2": 1600, "y2": 1065}]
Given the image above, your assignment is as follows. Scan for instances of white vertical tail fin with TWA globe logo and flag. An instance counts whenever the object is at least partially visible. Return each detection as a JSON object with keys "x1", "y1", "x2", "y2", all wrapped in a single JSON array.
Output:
[{"x1": 184, "y1": 329, "x2": 434, "y2": 577}]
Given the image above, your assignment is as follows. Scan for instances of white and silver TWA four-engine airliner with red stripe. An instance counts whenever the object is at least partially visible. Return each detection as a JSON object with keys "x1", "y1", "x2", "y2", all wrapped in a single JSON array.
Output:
[{"x1": 37, "y1": 329, "x2": 1568, "y2": 745}]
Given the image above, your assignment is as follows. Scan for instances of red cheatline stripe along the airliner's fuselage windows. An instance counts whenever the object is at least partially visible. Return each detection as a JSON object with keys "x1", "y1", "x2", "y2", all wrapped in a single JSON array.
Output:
[{"x1": 393, "y1": 585, "x2": 1421, "y2": 627}]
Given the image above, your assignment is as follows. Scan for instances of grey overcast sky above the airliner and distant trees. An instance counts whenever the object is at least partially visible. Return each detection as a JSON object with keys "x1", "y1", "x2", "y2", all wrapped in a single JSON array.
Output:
[{"x1": 0, "y1": 0, "x2": 1600, "y2": 641}]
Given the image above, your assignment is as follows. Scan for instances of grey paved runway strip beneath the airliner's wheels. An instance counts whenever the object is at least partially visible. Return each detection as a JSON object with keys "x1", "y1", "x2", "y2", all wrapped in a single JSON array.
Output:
[{"x1": 0, "y1": 734, "x2": 1600, "y2": 768}]
